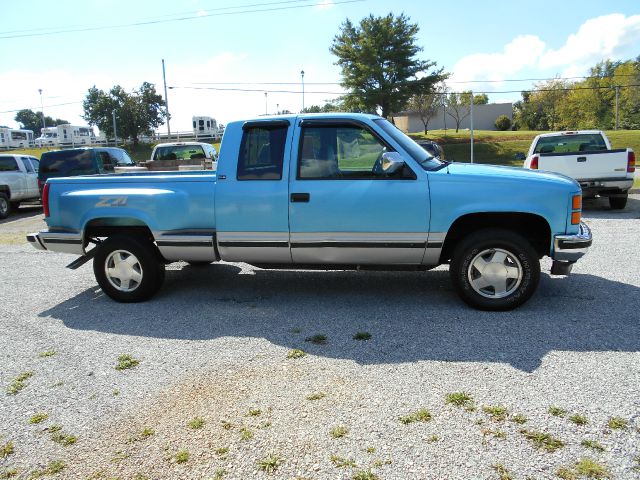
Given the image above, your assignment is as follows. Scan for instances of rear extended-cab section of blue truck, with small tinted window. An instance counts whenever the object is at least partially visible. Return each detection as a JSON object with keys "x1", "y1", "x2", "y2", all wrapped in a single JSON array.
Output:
[{"x1": 215, "y1": 120, "x2": 292, "y2": 263}]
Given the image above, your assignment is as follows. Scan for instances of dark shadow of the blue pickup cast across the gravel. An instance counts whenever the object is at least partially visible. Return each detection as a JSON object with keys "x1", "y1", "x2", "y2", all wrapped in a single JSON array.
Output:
[{"x1": 40, "y1": 264, "x2": 640, "y2": 372}]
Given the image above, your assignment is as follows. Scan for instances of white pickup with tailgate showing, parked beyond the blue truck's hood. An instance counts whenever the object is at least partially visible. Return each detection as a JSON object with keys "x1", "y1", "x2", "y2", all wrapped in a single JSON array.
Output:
[{"x1": 524, "y1": 130, "x2": 636, "y2": 209}]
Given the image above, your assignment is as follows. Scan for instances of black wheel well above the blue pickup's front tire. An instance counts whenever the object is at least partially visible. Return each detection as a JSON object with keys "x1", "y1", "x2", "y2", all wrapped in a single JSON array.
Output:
[{"x1": 440, "y1": 212, "x2": 551, "y2": 263}]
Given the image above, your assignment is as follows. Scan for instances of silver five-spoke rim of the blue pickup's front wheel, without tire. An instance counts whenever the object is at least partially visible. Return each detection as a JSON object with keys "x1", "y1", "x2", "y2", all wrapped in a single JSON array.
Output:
[{"x1": 467, "y1": 248, "x2": 523, "y2": 298}]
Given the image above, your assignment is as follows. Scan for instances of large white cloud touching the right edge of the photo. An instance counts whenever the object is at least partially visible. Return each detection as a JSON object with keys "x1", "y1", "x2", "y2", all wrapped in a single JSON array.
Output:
[{"x1": 540, "y1": 13, "x2": 640, "y2": 75}]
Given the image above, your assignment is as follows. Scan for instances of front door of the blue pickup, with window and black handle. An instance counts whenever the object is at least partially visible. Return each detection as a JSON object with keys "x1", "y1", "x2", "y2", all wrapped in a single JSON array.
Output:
[{"x1": 289, "y1": 119, "x2": 429, "y2": 265}]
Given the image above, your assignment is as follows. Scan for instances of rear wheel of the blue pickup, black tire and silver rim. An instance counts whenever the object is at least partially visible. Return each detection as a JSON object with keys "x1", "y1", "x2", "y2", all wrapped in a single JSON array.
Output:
[{"x1": 93, "y1": 235, "x2": 164, "y2": 303}]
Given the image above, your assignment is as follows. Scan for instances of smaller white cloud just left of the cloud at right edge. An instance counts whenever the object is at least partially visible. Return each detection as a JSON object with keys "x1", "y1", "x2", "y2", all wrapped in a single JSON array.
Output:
[{"x1": 451, "y1": 35, "x2": 545, "y2": 89}]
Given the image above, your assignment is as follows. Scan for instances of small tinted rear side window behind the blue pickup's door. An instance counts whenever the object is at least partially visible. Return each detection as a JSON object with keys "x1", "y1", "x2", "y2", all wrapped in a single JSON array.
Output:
[{"x1": 237, "y1": 125, "x2": 288, "y2": 180}]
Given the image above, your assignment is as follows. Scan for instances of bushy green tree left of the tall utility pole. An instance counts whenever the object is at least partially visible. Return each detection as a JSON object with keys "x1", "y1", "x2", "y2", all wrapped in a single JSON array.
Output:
[{"x1": 82, "y1": 82, "x2": 167, "y2": 146}]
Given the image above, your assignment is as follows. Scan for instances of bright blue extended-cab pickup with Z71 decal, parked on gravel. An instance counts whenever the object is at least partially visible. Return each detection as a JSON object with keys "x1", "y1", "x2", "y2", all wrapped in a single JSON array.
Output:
[{"x1": 28, "y1": 114, "x2": 591, "y2": 310}]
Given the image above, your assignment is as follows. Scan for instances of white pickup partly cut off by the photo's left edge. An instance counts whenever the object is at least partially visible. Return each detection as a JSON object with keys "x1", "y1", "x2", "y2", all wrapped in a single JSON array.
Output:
[{"x1": 0, "y1": 154, "x2": 40, "y2": 218}]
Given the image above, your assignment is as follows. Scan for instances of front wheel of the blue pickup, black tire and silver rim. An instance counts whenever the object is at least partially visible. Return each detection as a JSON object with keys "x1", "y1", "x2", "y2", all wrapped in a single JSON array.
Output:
[{"x1": 449, "y1": 229, "x2": 540, "y2": 311}]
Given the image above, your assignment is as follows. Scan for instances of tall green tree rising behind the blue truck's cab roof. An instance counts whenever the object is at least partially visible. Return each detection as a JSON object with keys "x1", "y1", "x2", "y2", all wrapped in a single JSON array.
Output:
[{"x1": 330, "y1": 13, "x2": 446, "y2": 117}]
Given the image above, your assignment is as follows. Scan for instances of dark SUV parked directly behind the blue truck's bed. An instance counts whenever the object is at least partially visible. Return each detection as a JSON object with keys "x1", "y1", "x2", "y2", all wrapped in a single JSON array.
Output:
[{"x1": 38, "y1": 147, "x2": 136, "y2": 192}]
